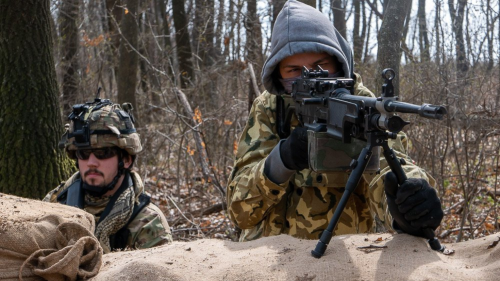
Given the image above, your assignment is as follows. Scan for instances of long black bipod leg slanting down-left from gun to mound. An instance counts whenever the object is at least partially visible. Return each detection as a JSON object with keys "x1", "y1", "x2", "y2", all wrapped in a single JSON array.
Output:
[{"x1": 311, "y1": 144, "x2": 372, "y2": 259}]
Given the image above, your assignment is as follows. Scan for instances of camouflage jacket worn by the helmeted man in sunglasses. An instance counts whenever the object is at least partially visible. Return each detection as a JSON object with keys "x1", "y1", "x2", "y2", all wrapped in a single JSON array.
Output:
[{"x1": 43, "y1": 171, "x2": 172, "y2": 249}]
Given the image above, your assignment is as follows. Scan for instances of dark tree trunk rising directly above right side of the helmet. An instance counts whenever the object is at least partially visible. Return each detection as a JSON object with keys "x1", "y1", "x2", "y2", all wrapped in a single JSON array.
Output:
[{"x1": 118, "y1": 0, "x2": 139, "y2": 109}]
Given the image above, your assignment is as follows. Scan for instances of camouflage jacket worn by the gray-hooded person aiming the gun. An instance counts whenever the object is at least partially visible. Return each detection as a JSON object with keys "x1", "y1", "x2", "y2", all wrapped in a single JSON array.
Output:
[{"x1": 227, "y1": 75, "x2": 434, "y2": 241}]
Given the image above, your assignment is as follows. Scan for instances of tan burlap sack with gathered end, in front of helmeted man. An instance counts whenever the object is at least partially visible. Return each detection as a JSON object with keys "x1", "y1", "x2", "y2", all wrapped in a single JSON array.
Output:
[{"x1": 0, "y1": 193, "x2": 102, "y2": 281}]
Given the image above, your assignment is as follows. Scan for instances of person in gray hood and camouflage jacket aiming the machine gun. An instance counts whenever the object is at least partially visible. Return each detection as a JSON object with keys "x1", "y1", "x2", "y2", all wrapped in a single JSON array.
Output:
[{"x1": 227, "y1": 1, "x2": 443, "y2": 241}]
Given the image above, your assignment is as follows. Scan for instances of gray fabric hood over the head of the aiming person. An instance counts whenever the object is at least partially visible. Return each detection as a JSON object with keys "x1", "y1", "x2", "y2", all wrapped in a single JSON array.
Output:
[{"x1": 262, "y1": 0, "x2": 354, "y2": 94}]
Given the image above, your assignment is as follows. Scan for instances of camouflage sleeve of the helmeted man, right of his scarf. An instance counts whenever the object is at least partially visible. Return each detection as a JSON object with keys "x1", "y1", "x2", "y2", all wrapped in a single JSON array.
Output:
[{"x1": 128, "y1": 203, "x2": 172, "y2": 249}]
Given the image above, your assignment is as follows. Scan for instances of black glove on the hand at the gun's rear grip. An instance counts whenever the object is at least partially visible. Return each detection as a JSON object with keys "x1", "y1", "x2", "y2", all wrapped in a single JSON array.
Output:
[{"x1": 280, "y1": 127, "x2": 309, "y2": 171}]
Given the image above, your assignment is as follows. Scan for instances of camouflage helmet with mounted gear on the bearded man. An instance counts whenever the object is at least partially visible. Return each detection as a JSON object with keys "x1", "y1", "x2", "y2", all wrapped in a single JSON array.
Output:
[{"x1": 59, "y1": 98, "x2": 142, "y2": 159}]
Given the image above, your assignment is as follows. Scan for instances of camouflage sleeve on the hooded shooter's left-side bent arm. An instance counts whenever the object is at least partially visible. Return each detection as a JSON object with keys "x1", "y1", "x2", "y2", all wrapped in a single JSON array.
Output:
[{"x1": 227, "y1": 92, "x2": 288, "y2": 229}]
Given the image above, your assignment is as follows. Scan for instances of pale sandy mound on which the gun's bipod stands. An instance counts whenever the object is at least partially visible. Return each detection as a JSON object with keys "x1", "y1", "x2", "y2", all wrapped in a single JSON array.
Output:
[{"x1": 92, "y1": 234, "x2": 500, "y2": 281}]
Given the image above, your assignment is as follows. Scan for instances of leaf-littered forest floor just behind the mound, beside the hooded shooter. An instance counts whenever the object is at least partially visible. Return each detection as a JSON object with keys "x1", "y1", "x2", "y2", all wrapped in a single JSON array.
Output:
[{"x1": 145, "y1": 167, "x2": 500, "y2": 243}]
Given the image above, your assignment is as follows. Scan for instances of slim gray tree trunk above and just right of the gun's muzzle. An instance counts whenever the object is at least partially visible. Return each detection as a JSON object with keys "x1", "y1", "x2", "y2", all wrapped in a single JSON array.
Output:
[{"x1": 448, "y1": 0, "x2": 469, "y2": 80}]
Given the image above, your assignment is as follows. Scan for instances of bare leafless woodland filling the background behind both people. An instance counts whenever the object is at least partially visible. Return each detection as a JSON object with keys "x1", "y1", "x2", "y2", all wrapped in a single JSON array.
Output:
[{"x1": 0, "y1": 0, "x2": 500, "y2": 241}]
